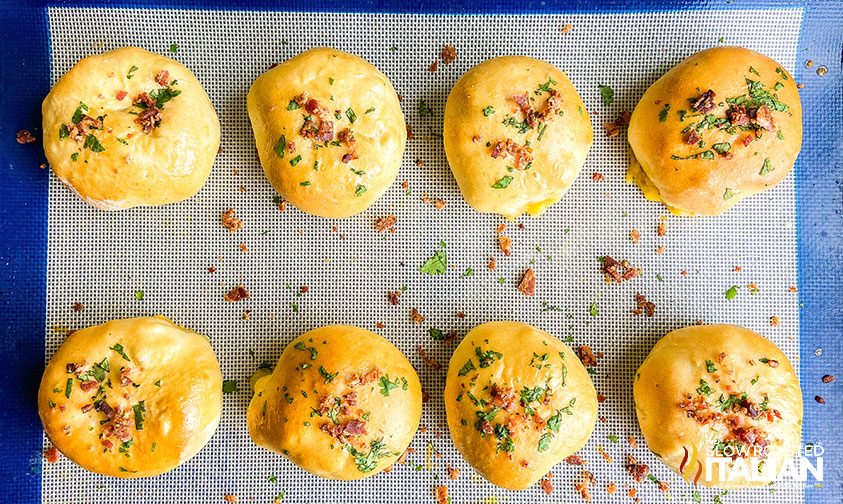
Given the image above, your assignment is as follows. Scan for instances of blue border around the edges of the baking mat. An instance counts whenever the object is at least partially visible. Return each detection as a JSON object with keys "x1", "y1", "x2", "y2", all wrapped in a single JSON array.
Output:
[{"x1": 0, "y1": 0, "x2": 843, "y2": 503}]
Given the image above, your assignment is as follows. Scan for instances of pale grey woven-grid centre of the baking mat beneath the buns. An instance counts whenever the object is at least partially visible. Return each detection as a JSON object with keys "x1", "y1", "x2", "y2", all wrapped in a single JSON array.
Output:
[{"x1": 43, "y1": 8, "x2": 802, "y2": 503}]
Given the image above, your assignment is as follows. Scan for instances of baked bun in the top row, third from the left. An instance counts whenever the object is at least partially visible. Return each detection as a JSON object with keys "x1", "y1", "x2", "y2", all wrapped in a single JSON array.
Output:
[{"x1": 444, "y1": 56, "x2": 592, "y2": 219}]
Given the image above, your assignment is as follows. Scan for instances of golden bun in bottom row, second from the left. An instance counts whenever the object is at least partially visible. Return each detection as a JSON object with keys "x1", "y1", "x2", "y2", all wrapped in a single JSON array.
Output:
[{"x1": 247, "y1": 325, "x2": 422, "y2": 480}]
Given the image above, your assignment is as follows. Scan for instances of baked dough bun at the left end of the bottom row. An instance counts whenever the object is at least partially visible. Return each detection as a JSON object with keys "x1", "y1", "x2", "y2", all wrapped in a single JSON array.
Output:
[{"x1": 38, "y1": 316, "x2": 222, "y2": 478}]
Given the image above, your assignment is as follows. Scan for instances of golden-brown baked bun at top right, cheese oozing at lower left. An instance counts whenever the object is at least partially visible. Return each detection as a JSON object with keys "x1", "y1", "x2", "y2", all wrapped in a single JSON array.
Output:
[{"x1": 627, "y1": 47, "x2": 802, "y2": 215}]
